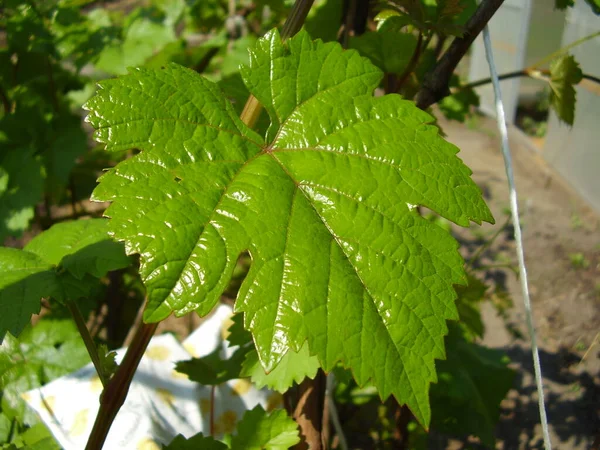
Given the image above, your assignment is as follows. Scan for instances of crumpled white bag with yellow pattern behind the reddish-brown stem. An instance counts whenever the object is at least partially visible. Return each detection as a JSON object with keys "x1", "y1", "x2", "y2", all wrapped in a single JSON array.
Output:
[{"x1": 23, "y1": 305, "x2": 281, "y2": 450}]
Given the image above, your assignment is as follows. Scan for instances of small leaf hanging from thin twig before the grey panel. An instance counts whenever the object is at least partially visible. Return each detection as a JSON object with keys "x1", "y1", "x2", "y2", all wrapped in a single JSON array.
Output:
[{"x1": 550, "y1": 54, "x2": 583, "y2": 126}]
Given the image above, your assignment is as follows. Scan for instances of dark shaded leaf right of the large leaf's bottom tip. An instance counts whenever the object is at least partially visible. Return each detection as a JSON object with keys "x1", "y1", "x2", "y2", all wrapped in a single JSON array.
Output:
[{"x1": 431, "y1": 325, "x2": 515, "y2": 448}]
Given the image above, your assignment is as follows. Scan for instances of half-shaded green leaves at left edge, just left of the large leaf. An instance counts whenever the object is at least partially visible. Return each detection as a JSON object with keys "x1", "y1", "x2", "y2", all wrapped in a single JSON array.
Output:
[{"x1": 0, "y1": 219, "x2": 130, "y2": 342}]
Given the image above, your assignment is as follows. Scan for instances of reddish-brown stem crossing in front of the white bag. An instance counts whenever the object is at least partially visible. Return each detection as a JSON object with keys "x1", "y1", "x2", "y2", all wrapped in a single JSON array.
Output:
[{"x1": 85, "y1": 323, "x2": 158, "y2": 450}]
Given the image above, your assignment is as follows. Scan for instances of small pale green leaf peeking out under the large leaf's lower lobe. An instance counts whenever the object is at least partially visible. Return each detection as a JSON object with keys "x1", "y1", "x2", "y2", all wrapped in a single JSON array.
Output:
[{"x1": 240, "y1": 343, "x2": 321, "y2": 393}]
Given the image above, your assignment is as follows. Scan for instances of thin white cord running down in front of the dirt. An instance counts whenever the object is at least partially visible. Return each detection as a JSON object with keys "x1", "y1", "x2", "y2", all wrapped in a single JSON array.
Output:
[{"x1": 483, "y1": 25, "x2": 552, "y2": 450}]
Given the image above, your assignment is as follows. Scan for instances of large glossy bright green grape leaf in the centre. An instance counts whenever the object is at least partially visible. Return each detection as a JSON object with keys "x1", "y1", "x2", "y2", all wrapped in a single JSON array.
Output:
[{"x1": 87, "y1": 32, "x2": 493, "y2": 423}]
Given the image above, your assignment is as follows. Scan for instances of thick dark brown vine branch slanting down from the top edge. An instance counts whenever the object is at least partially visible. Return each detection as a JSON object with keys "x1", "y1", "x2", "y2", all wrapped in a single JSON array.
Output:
[{"x1": 417, "y1": 0, "x2": 504, "y2": 109}]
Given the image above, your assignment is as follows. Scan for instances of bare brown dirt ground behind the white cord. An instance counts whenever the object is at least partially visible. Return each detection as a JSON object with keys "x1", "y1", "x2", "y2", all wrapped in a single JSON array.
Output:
[{"x1": 439, "y1": 113, "x2": 600, "y2": 450}]
